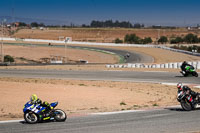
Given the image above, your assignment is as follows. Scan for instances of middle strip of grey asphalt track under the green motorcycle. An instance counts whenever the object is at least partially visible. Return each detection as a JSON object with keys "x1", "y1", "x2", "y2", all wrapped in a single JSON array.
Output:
[{"x1": 0, "y1": 69, "x2": 200, "y2": 84}]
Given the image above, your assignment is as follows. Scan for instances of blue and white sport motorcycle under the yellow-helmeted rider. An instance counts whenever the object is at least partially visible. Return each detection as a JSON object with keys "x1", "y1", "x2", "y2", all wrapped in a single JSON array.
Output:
[{"x1": 23, "y1": 102, "x2": 67, "y2": 124}]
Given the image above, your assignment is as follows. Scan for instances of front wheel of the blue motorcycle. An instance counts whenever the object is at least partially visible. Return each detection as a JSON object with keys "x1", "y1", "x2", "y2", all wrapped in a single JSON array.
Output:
[{"x1": 24, "y1": 112, "x2": 39, "y2": 124}]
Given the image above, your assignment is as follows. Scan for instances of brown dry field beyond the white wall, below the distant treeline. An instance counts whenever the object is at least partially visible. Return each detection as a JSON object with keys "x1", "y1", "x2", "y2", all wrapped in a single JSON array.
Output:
[{"x1": 12, "y1": 28, "x2": 200, "y2": 42}]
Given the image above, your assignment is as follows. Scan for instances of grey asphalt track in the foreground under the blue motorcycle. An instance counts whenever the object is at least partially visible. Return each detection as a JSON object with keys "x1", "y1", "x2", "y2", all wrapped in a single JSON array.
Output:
[{"x1": 0, "y1": 107, "x2": 200, "y2": 133}]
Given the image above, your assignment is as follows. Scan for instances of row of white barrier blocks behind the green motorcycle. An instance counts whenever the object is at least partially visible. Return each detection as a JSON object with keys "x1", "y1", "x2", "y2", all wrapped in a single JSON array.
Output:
[{"x1": 106, "y1": 61, "x2": 200, "y2": 69}]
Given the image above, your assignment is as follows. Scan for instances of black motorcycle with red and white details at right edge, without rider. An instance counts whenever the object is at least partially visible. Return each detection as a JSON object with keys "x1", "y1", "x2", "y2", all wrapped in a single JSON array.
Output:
[{"x1": 177, "y1": 90, "x2": 199, "y2": 111}]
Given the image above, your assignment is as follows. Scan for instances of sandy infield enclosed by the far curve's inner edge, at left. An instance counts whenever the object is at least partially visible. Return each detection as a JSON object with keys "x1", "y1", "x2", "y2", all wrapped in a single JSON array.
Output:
[{"x1": 1, "y1": 45, "x2": 119, "y2": 63}]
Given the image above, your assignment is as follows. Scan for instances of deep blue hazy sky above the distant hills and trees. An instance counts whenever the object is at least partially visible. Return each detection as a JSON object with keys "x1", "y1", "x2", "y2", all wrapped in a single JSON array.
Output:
[{"x1": 0, "y1": 0, "x2": 200, "y2": 26}]
